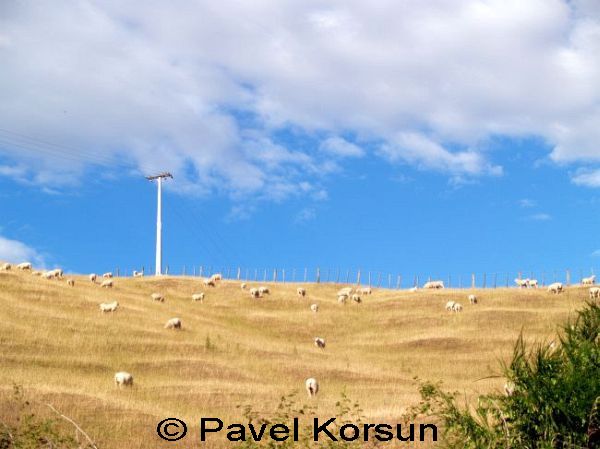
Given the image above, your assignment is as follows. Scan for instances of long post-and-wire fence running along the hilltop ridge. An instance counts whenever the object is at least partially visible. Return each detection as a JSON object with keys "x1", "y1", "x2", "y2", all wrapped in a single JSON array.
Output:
[{"x1": 114, "y1": 265, "x2": 595, "y2": 289}]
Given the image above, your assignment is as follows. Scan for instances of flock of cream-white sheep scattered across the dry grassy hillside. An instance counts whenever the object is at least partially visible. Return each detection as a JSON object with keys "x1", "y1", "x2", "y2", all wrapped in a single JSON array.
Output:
[{"x1": 0, "y1": 262, "x2": 600, "y2": 397}]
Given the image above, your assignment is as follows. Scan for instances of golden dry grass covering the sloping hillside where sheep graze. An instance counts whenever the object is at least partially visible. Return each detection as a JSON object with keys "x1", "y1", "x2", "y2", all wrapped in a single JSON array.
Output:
[{"x1": 0, "y1": 264, "x2": 587, "y2": 449}]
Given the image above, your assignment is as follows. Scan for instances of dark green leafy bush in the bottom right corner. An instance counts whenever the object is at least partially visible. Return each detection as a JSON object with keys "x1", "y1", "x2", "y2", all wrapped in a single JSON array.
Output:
[{"x1": 412, "y1": 303, "x2": 600, "y2": 449}]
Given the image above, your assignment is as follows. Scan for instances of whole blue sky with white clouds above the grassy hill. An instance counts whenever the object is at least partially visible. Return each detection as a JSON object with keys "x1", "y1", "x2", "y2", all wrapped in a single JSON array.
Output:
[{"x1": 0, "y1": 0, "x2": 600, "y2": 286}]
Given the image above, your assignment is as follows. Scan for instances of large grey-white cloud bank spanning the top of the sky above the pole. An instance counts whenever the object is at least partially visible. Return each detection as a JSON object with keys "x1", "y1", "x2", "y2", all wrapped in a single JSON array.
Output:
[{"x1": 0, "y1": 0, "x2": 600, "y2": 199}]
